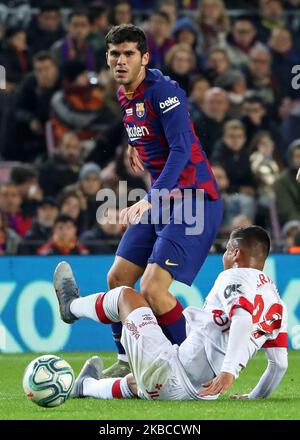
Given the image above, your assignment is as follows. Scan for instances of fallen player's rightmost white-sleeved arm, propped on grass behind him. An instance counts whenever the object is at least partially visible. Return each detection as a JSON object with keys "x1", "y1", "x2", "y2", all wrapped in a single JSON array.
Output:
[{"x1": 232, "y1": 347, "x2": 288, "y2": 400}]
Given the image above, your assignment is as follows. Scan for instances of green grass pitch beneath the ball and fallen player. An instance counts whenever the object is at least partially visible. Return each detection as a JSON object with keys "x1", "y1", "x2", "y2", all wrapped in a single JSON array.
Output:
[{"x1": 0, "y1": 351, "x2": 300, "y2": 420}]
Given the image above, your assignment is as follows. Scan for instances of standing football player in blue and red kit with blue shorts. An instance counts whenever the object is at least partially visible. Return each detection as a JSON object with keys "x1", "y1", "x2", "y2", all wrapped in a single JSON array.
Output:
[{"x1": 104, "y1": 25, "x2": 223, "y2": 377}]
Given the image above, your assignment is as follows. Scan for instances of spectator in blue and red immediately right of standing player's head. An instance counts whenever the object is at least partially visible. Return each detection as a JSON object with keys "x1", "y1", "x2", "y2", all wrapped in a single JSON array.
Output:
[{"x1": 146, "y1": 11, "x2": 174, "y2": 69}]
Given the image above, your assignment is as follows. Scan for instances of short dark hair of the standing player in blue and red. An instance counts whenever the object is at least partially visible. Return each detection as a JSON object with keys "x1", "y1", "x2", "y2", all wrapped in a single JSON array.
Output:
[{"x1": 105, "y1": 24, "x2": 148, "y2": 55}]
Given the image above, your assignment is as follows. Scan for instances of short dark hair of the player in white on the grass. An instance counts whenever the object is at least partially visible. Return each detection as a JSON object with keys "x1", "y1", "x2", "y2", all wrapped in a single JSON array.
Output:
[{"x1": 230, "y1": 225, "x2": 271, "y2": 258}]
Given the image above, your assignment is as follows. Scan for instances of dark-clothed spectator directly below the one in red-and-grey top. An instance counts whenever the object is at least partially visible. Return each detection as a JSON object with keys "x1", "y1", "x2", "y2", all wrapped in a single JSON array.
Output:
[{"x1": 39, "y1": 132, "x2": 82, "y2": 197}]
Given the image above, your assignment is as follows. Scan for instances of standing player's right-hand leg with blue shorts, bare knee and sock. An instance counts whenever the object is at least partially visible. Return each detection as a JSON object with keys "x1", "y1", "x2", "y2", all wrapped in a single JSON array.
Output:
[{"x1": 141, "y1": 197, "x2": 223, "y2": 344}]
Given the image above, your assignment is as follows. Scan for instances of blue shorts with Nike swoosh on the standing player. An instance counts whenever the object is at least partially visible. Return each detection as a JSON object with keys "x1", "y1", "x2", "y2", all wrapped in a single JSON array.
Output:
[{"x1": 116, "y1": 195, "x2": 223, "y2": 286}]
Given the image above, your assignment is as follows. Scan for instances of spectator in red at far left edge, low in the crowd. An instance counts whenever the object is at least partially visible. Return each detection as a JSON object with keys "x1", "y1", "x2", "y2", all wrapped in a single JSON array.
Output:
[{"x1": 0, "y1": 182, "x2": 32, "y2": 237}]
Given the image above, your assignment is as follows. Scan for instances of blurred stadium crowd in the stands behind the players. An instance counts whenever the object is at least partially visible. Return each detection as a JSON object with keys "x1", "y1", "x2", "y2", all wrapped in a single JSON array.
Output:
[{"x1": 0, "y1": 0, "x2": 300, "y2": 255}]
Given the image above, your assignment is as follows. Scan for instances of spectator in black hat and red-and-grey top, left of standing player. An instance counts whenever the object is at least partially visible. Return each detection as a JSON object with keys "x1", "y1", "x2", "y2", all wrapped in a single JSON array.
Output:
[{"x1": 51, "y1": 60, "x2": 114, "y2": 149}]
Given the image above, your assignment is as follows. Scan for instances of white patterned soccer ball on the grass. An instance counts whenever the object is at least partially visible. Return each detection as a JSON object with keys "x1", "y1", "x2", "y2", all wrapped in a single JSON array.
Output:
[{"x1": 23, "y1": 354, "x2": 74, "y2": 407}]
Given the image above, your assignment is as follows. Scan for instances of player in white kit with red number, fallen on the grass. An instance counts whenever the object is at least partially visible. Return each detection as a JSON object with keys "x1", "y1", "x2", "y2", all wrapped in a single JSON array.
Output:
[{"x1": 54, "y1": 226, "x2": 287, "y2": 400}]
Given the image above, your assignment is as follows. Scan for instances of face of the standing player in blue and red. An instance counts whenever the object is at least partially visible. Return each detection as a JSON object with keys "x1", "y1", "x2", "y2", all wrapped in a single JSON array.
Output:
[{"x1": 106, "y1": 42, "x2": 149, "y2": 86}]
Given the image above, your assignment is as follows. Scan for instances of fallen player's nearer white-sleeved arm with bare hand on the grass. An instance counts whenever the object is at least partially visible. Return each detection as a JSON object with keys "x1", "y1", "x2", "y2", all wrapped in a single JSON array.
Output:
[{"x1": 199, "y1": 307, "x2": 252, "y2": 397}]
